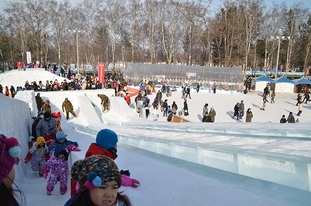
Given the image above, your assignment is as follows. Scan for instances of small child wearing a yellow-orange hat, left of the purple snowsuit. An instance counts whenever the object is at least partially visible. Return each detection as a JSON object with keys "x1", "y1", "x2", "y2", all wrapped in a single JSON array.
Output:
[{"x1": 25, "y1": 137, "x2": 50, "y2": 177}]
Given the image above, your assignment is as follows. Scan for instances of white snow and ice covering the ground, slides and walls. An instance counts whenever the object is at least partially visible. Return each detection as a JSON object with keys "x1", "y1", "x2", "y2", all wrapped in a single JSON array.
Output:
[{"x1": 0, "y1": 69, "x2": 311, "y2": 206}]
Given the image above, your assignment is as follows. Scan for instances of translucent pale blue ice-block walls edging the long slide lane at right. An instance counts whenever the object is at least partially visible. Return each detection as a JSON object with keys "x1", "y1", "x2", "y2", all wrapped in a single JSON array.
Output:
[{"x1": 77, "y1": 123, "x2": 311, "y2": 191}]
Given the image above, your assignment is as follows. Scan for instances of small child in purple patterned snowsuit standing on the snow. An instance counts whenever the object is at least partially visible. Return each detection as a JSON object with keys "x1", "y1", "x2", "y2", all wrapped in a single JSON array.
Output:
[{"x1": 42, "y1": 145, "x2": 69, "y2": 195}]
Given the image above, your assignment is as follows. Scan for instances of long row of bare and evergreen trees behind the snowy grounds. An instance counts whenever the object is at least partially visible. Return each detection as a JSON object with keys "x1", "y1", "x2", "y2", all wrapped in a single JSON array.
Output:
[{"x1": 0, "y1": 0, "x2": 311, "y2": 74}]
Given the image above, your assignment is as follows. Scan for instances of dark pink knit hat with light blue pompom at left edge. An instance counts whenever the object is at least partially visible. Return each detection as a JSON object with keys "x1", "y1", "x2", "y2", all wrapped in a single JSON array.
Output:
[{"x1": 0, "y1": 134, "x2": 21, "y2": 184}]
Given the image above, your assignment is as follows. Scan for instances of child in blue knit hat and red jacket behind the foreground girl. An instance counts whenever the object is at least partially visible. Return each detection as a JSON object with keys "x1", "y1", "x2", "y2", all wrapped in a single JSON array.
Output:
[{"x1": 71, "y1": 129, "x2": 139, "y2": 195}]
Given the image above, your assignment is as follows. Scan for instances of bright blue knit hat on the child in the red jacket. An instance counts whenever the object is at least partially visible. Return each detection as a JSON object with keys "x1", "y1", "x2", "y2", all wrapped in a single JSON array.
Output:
[{"x1": 96, "y1": 129, "x2": 118, "y2": 149}]
